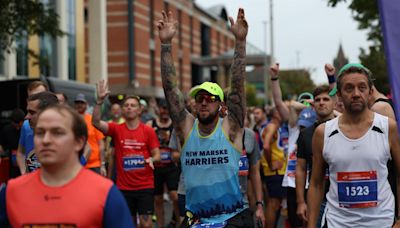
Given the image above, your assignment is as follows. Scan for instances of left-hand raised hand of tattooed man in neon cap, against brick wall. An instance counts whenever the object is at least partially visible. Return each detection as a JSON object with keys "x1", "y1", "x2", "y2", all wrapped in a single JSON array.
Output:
[{"x1": 157, "y1": 11, "x2": 178, "y2": 44}]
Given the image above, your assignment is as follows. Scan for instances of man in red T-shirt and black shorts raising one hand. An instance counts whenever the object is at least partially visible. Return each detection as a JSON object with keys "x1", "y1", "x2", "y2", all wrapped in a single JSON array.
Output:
[{"x1": 92, "y1": 80, "x2": 161, "y2": 228}]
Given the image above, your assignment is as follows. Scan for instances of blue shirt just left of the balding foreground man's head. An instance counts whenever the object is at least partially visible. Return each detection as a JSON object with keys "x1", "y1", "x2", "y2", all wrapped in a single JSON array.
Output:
[{"x1": 19, "y1": 120, "x2": 40, "y2": 172}]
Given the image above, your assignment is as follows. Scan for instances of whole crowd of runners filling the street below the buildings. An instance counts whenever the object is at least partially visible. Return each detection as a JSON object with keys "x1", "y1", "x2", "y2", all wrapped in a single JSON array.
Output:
[{"x1": 0, "y1": 9, "x2": 400, "y2": 228}]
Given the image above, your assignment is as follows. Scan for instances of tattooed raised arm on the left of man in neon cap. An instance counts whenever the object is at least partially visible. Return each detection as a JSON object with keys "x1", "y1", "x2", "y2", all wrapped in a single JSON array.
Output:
[{"x1": 157, "y1": 11, "x2": 194, "y2": 144}]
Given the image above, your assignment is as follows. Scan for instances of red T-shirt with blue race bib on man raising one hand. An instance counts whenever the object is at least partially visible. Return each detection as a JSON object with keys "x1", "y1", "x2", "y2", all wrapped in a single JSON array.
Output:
[{"x1": 108, "y1": 123, "x2": 160, "y2": 190}]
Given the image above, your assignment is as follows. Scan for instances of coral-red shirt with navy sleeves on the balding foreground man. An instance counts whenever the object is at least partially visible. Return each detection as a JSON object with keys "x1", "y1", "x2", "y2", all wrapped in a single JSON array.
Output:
[{"x1": 0, "y1": 169, "x2": 134, "y2": 227}]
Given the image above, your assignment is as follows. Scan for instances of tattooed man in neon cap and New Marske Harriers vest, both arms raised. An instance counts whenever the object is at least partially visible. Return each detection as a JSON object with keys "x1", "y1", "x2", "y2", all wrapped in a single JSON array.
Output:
[{"x1": 157, "y1": 9, "x2": 252, "y2": 227}]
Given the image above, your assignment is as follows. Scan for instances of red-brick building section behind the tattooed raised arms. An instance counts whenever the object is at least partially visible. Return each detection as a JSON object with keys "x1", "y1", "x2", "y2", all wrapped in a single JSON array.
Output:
[{"x1": 101, "y1": 0, "x2": 238, "y2": 97}]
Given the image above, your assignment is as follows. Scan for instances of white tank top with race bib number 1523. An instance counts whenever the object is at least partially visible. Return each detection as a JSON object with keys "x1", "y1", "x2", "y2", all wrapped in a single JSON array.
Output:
[{"x1": 322, "y1": 113, "x2": 394, "y2": 228}]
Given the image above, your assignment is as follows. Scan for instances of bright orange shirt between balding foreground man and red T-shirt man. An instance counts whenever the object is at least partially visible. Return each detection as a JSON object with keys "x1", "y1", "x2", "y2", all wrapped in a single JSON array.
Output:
[{"x1": 84, "y1": 113, "x2": 104, "y2": 168}]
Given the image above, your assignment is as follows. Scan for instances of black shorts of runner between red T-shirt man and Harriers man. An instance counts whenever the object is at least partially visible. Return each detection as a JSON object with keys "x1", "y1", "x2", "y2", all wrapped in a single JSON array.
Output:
[{"x1": 154, "y1": 163, "x2": 180, "y2": 195}]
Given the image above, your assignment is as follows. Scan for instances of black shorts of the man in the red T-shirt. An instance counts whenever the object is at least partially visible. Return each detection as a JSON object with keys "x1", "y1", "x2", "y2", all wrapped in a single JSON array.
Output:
[{"x1": 121, "y1": 188, "x2": 154, "y2": 216}]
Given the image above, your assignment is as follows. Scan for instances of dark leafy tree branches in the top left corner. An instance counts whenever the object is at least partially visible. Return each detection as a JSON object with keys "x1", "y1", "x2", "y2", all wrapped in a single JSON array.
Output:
[{"x1": 0, "y1": 0, "x2": 65, "y2": 57}]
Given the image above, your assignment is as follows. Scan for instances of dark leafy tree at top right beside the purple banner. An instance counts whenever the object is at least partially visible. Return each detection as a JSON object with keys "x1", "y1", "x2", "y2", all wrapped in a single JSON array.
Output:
[{"x1": 328, "y1": 0, "x2": 390, "y2": 93}]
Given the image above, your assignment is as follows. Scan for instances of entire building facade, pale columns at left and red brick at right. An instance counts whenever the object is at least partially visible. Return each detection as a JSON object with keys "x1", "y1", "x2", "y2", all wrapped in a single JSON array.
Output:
[{"x1": 0, "y1": 0, "x2": 238, "y2": 97}]
